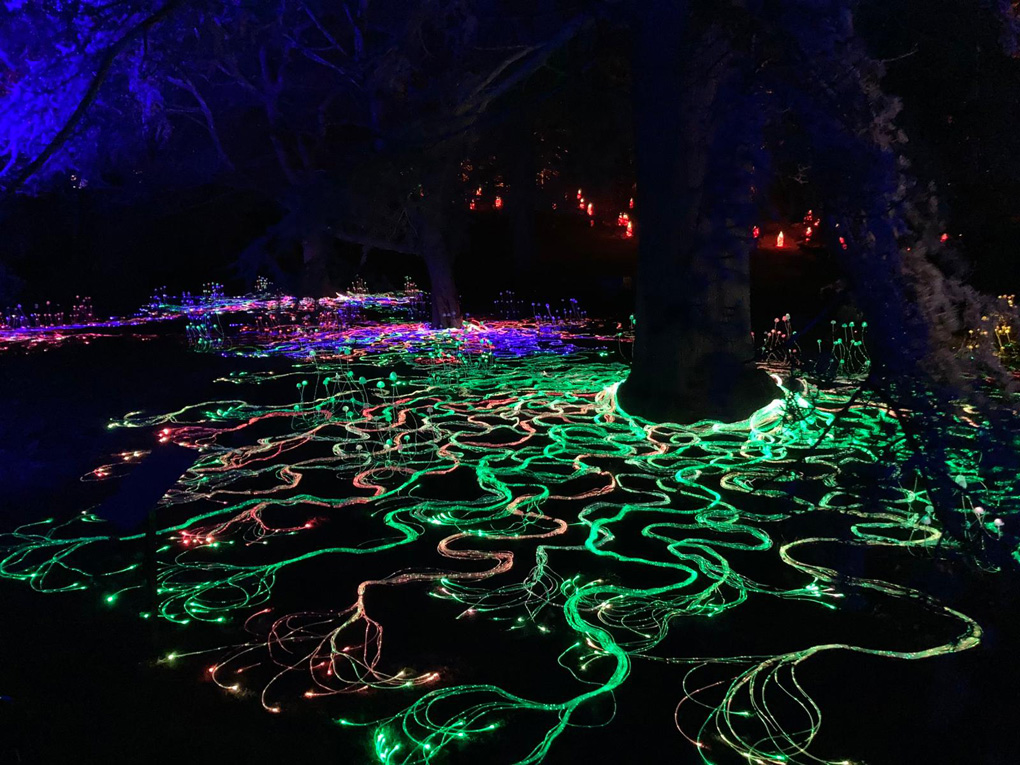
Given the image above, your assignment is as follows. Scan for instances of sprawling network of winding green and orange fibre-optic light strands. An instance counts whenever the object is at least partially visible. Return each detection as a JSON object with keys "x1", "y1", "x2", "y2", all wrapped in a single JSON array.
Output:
[{"x1": 0, "y1": 295, "x2": 1004, "y2": 765}]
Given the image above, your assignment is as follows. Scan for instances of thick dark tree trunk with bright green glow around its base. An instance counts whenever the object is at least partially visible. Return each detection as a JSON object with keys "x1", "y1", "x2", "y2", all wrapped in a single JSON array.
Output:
[{"x1": 620, "y1": 0, "x2": 777, "y2": 421}]
